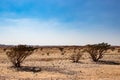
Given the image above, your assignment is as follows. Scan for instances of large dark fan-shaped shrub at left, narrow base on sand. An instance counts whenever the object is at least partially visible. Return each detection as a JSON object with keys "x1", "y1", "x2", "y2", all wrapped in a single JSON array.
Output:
[{"x1": 5, "y1": 45, "x2": 37, "y2": 68}]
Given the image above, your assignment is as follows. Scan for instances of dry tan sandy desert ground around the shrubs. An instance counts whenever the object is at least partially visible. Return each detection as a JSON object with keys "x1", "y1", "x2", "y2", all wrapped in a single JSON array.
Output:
[{"x1": 0, "y1": 47, "x2": 120, "y2": 80}]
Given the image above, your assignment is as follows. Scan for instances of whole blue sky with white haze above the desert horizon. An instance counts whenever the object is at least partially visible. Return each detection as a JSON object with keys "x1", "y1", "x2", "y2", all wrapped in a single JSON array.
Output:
[{"x1": 0, "y1": 0, "x2": 120, "y2": 45}]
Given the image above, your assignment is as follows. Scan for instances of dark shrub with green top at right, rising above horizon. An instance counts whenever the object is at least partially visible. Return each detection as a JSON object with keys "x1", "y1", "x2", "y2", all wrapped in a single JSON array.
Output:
[{"x1": 86, "y1": 43, "x2": 110, "y2": 62}]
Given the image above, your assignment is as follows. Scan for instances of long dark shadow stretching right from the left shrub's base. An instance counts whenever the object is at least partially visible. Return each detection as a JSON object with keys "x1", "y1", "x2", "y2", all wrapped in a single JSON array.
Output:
[{"x1": 11, "y1": 66, "x2": 77, "y2": 75}]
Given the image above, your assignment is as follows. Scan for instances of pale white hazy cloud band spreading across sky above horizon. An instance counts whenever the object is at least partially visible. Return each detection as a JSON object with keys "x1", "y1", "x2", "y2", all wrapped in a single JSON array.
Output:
[{"x1": 0, "y1": 18, "x2": 120, "y2": 45}]
